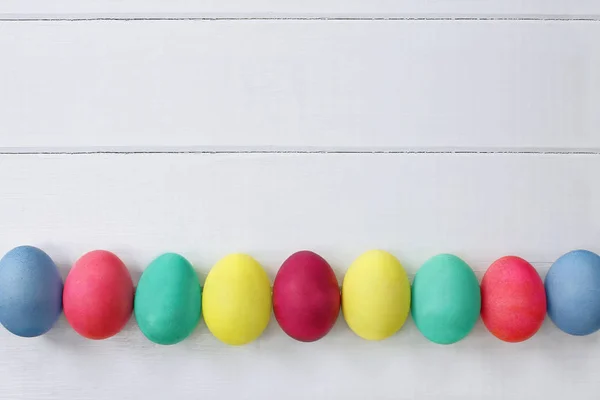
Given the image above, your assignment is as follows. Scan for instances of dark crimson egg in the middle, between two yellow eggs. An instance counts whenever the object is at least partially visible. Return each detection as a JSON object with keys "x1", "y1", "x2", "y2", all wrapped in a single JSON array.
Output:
[{"x1": 273, "y1": 251, "x2": 340, "y2": 342}]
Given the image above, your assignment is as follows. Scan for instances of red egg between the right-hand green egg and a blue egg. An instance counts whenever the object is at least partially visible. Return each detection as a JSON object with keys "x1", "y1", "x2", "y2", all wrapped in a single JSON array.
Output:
[{"x1": 481, "y1": 256, "x2": 546, "y2": 342}]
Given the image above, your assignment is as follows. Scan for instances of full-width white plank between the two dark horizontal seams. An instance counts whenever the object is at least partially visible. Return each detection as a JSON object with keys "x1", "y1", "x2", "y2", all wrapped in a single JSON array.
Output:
[{"x1": 0, "y1": 20, "x2": 600, "y2": 152}]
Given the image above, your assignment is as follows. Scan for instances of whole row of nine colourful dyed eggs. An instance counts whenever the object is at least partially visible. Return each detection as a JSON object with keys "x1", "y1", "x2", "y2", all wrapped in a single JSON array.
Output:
[{"x1": 0, "y1": 246, "x2": 600, "y2": 345}]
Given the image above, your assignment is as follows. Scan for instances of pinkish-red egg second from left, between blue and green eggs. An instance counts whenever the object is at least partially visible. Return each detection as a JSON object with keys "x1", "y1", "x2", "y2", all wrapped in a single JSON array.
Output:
[{"x1": 63, "y1": 250, "x2": 134, "y2": 339}]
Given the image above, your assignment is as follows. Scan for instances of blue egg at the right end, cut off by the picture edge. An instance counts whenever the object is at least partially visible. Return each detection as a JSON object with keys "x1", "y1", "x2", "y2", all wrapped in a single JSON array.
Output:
[{"x1": 544, "y1": 250, "x2": 600, "y2": 336}]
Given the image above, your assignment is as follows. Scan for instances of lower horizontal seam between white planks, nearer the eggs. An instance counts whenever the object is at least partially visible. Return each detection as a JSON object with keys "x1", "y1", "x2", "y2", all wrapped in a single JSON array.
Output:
[{"x1": 0, "y1": 150, "x2": 600, "y2": 155}]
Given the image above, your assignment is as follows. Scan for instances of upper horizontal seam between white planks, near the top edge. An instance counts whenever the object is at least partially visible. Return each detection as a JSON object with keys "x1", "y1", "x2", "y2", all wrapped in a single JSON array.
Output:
[{"x1": 0, "y1": 13, "x2": 600, "y2": 22}]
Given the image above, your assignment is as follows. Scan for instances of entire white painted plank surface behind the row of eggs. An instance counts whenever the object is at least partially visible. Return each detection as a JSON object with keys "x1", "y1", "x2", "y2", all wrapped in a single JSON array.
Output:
[{"x1": 0, "y1": 0, "x2": 600, "y2": 400}]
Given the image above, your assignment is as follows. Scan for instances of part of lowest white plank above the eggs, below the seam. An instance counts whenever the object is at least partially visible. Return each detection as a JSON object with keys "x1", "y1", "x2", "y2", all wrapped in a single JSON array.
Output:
[{"x1": 0, "y1": 154, "x2": 600, "y2": 277}]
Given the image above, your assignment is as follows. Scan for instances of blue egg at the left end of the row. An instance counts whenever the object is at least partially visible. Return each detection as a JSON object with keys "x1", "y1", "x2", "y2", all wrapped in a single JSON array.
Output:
[{"x1": 0, "y1": 246, "x2": 63, "y2": 337}]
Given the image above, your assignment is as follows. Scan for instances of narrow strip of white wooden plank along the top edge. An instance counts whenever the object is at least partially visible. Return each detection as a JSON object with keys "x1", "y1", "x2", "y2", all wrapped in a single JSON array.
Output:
[{"x1": 0, "y1": 0, "x2": 600, "y2": 18}]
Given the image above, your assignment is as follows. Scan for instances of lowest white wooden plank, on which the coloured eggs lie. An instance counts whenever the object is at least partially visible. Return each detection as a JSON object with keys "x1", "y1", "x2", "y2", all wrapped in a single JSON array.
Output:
[{"x1": 0, "y1": 154, "x2": 600, "y2": 400}]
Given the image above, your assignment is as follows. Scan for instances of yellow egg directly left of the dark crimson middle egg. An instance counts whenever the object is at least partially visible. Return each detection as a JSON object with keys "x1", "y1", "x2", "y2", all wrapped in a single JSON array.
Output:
[{"x1": 202, "y1": 254, "x2": 271, "y2": 345}]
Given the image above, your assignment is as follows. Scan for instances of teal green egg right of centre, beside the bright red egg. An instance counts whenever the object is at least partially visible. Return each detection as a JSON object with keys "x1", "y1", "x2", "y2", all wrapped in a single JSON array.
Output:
[{"x1": 412, "y1": 254, "x2": 481, "y2": 344}]
